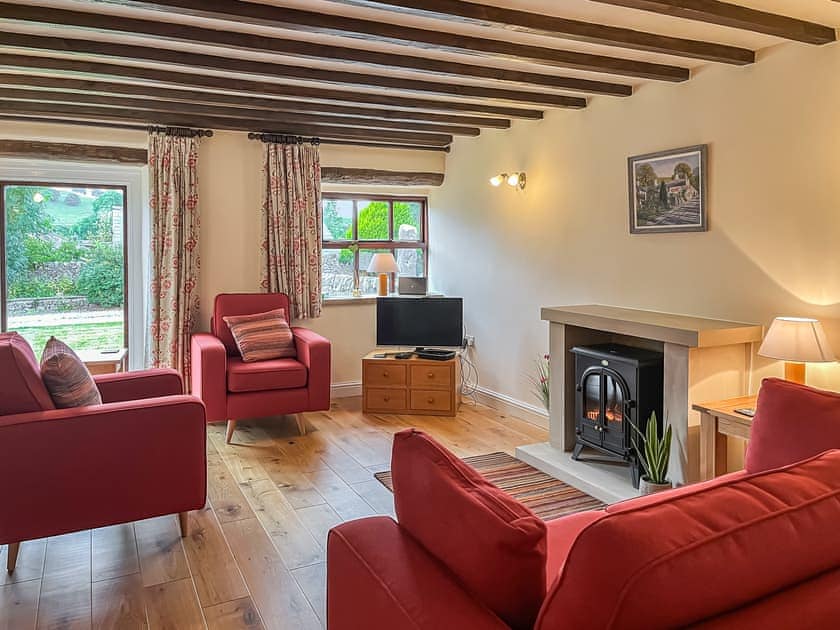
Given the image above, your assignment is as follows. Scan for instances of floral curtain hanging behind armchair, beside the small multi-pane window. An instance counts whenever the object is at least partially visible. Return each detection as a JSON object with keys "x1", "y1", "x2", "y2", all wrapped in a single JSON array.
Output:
[{"x1": 262, "y1": 143, "x2": 323, "y2": 319}]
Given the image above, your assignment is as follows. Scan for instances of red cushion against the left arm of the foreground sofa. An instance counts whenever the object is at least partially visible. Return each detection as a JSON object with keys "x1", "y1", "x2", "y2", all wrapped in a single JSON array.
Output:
[{"x1": 391, "y1": 429, "x2": 546, "y2": 628}]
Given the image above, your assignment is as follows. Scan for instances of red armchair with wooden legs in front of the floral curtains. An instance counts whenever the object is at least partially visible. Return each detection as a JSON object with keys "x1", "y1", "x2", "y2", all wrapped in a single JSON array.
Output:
[{"x1": 191, "y1": 293, "x2": 331, "y2": 444}]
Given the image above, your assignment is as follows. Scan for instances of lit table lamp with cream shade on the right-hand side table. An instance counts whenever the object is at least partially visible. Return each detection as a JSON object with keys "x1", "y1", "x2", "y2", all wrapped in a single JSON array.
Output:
[{"x1": 758, "y1": 317, "x2": 836, "y2": 384}]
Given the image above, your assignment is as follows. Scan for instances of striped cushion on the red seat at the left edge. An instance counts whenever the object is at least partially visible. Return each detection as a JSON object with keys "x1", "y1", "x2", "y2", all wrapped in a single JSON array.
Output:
[{"x1": 41, "y1": 337, "x2": 102, "y2": 409}]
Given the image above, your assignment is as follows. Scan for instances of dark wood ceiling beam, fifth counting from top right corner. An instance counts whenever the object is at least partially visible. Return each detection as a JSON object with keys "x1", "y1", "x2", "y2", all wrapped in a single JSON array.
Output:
[{"x1": 0, "y1": 32, "x2": 586, "y2": 108}]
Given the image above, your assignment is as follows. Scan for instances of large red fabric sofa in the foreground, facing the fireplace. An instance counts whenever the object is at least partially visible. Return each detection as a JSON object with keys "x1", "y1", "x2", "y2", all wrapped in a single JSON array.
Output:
[{"x1": 327, "y1": 383, "x2": 840, "y2": 630}]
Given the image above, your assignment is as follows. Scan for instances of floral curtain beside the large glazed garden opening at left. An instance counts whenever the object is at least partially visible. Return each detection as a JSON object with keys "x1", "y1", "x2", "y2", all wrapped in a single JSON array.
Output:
[{"x1": 149, "y1": 132, "x2": 200, "y2": 383}]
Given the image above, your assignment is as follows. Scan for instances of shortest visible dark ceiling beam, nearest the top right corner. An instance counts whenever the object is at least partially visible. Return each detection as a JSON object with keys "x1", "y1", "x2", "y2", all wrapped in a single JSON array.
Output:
[{"x1": 595, "y1": 0, "x2": 837, "y2": 44}]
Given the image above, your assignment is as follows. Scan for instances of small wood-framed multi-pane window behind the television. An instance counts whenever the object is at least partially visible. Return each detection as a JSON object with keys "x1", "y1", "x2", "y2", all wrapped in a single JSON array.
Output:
[{"x1": 322, "y1": 193, "x2": 429, "y2": 298}]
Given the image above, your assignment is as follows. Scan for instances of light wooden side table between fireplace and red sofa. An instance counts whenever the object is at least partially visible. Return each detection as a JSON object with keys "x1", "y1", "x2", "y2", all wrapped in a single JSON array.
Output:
[{"x1": 692, "y1": 396, "x2": 757, "y2": 481}]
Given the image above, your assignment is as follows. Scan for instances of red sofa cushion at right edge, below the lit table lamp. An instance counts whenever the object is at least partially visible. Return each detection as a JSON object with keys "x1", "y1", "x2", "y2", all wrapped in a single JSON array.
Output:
[{"x1": 746, "y1": 378, "x2": 840, "y2": 473}]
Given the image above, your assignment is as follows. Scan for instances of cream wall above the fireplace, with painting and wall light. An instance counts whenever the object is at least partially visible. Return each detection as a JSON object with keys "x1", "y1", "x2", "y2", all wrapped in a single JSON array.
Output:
[{"x1": 430, "y1": 39, "x2": 840, "y2": 410}]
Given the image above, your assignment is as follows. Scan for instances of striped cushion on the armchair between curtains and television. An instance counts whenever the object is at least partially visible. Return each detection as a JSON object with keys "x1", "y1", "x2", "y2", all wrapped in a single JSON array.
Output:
[{"x1": 222, "y1": 308, "x2": 297, "y2": 363}]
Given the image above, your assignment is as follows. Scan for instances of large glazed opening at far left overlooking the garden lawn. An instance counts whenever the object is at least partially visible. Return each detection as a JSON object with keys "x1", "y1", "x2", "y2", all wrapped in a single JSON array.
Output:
[{"x1": 0, "y1": 182, "x2": 128, "y2": 354}]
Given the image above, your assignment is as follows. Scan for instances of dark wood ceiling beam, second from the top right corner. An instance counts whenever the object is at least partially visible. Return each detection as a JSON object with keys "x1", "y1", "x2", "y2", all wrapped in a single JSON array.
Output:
[{"x1": 345, "y1": 0, "x2": 756, "y2": 65}]
